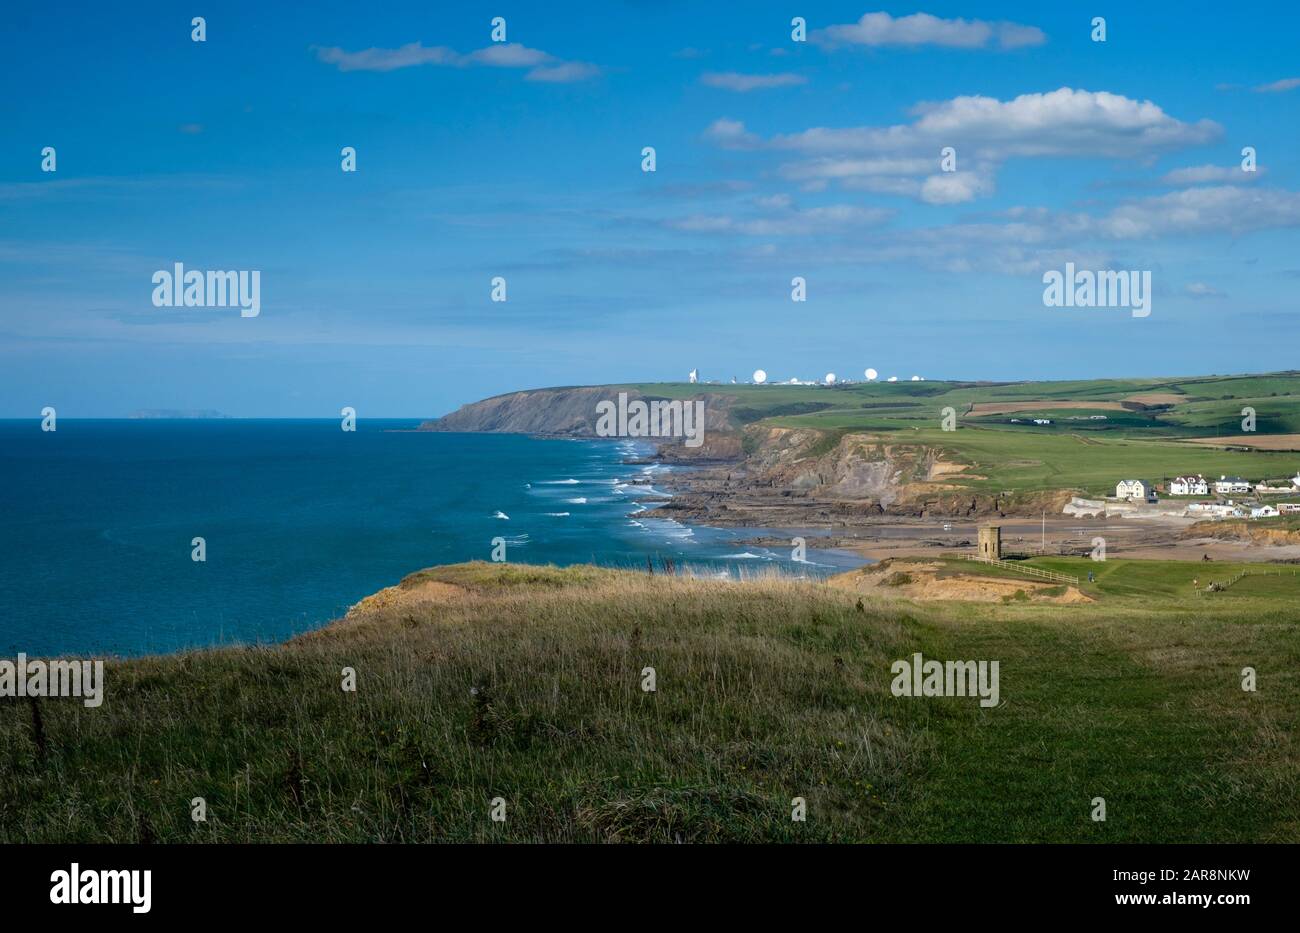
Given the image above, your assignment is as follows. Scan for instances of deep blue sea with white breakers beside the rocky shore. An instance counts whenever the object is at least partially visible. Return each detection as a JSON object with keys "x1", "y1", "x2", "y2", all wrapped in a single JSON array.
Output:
[{"x1": 0, "y1": 418, "x2": 862, "y2": 658}]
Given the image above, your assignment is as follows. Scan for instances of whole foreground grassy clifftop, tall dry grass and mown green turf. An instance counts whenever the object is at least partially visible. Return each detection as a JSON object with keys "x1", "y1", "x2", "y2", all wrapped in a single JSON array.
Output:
[{"x1": 0, "y1": 559, "x2": 1300, "y2": 842}]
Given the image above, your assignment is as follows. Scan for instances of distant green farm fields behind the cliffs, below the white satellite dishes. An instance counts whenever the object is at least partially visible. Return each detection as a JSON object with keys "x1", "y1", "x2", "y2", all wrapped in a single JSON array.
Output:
[{"x1": 634, "y1": 373, "x2": 1300, "y2": 495}]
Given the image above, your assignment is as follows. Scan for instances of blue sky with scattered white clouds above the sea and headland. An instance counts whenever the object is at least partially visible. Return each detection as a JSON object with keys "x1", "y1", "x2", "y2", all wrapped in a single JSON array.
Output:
[{"x1": 0, "y1": 1, "x2": 1300, "y2": 417}]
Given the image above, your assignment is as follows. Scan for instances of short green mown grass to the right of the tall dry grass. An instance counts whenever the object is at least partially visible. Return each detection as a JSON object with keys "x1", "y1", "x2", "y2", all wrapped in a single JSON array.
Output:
[{"x1": 852, "y1": 557, "x2": 1300, "y2": 842}]
